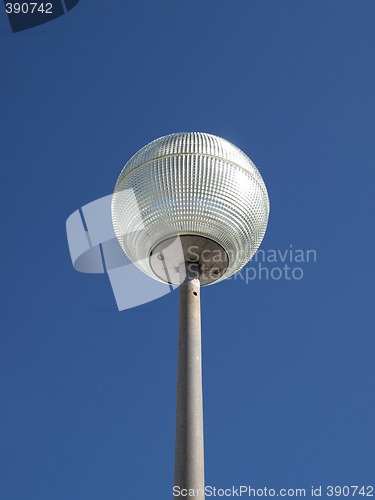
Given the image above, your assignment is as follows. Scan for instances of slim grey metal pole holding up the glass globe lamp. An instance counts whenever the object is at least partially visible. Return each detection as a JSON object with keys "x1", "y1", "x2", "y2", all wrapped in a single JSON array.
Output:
[{"x1": 173, "y1": 263, "x2": 205, "y2": 499}]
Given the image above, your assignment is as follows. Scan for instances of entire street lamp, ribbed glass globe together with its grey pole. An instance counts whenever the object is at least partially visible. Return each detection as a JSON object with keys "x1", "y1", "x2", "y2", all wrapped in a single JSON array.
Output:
[{"x1": 112, "y1": 133, "x2": 269, "y2": 498}]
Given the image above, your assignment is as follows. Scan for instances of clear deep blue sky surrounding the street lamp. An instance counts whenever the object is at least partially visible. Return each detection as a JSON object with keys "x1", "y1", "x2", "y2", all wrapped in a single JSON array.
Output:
[{"x1": 0, "y1": 0, "x2": 375, "y2": 500}]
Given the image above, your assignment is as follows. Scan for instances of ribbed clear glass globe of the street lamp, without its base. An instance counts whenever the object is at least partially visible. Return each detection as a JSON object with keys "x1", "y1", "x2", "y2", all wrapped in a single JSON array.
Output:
[{"x1": 112, "y1": 132, "x2": 269, "y2": 282}]
